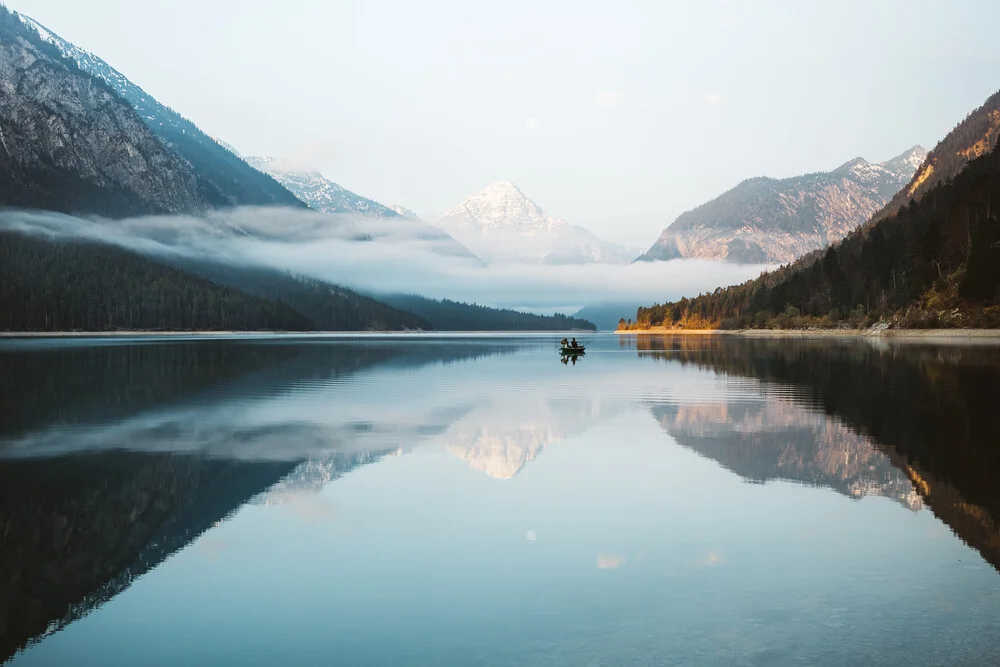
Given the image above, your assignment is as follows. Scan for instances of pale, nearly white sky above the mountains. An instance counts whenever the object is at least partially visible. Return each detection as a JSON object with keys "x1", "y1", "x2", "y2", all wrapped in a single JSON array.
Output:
[{"x1": 6, "y1": 0, "x2": 1000, "y2": 247}]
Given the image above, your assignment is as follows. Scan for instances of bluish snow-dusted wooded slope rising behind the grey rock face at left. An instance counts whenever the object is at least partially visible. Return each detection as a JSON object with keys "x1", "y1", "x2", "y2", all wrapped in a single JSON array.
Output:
[{"x1": 12, "y1": 10, "x2": 302, "y2": 207}]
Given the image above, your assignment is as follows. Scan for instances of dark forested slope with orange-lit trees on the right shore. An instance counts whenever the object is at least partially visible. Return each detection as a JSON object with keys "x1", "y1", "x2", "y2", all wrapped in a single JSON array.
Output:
[{"x1": 635, "y1": 95, "x2": 1000, "y2": 328}]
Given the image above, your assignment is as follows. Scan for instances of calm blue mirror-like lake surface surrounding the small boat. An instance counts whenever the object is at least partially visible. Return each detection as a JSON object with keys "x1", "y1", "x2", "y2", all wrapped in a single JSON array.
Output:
[{"x1": 0, "y1": 335, "x2": 1000, "y2": 667}]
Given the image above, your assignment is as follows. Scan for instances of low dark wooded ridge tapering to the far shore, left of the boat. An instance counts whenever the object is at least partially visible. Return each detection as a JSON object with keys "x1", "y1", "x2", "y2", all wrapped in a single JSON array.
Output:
[{"x1": 378, "y1": 294, "x2": 596, "y2": 331}]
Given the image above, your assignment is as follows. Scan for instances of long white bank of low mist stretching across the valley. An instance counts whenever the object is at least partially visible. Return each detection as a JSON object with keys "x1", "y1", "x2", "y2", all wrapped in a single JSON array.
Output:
[{"x1": 0, "y1": 207, "x2": 765, "y2": 314}]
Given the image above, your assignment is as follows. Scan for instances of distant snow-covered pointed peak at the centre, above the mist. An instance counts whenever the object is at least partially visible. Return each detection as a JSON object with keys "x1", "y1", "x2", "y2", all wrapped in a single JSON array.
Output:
[{"x1": 435, "y1": 181, "x2": 635, "y2": 264}]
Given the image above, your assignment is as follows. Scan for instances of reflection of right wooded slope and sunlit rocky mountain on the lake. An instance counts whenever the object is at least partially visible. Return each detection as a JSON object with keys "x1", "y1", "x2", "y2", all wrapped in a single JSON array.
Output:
[{"x1": 626, "y1": 336, "x2": 1000, "y2": 569}]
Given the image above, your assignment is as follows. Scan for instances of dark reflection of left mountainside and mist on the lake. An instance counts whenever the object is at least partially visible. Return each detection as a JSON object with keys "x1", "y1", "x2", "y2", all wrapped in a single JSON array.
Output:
[{"x1": 0, "y1": 340, "x2": 511, "y2": 660}]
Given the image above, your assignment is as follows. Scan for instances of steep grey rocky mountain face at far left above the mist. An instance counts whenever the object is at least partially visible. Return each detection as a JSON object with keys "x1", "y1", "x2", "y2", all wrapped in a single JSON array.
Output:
[{"x1": 0, "y1": 6, "x2": 209, "y2": 215}]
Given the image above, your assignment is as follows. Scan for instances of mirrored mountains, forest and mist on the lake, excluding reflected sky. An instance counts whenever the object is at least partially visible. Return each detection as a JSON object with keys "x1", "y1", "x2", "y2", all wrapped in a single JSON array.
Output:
[{"x1": 0, "y1": 336, "x2": 1000, "y2": 664}]
